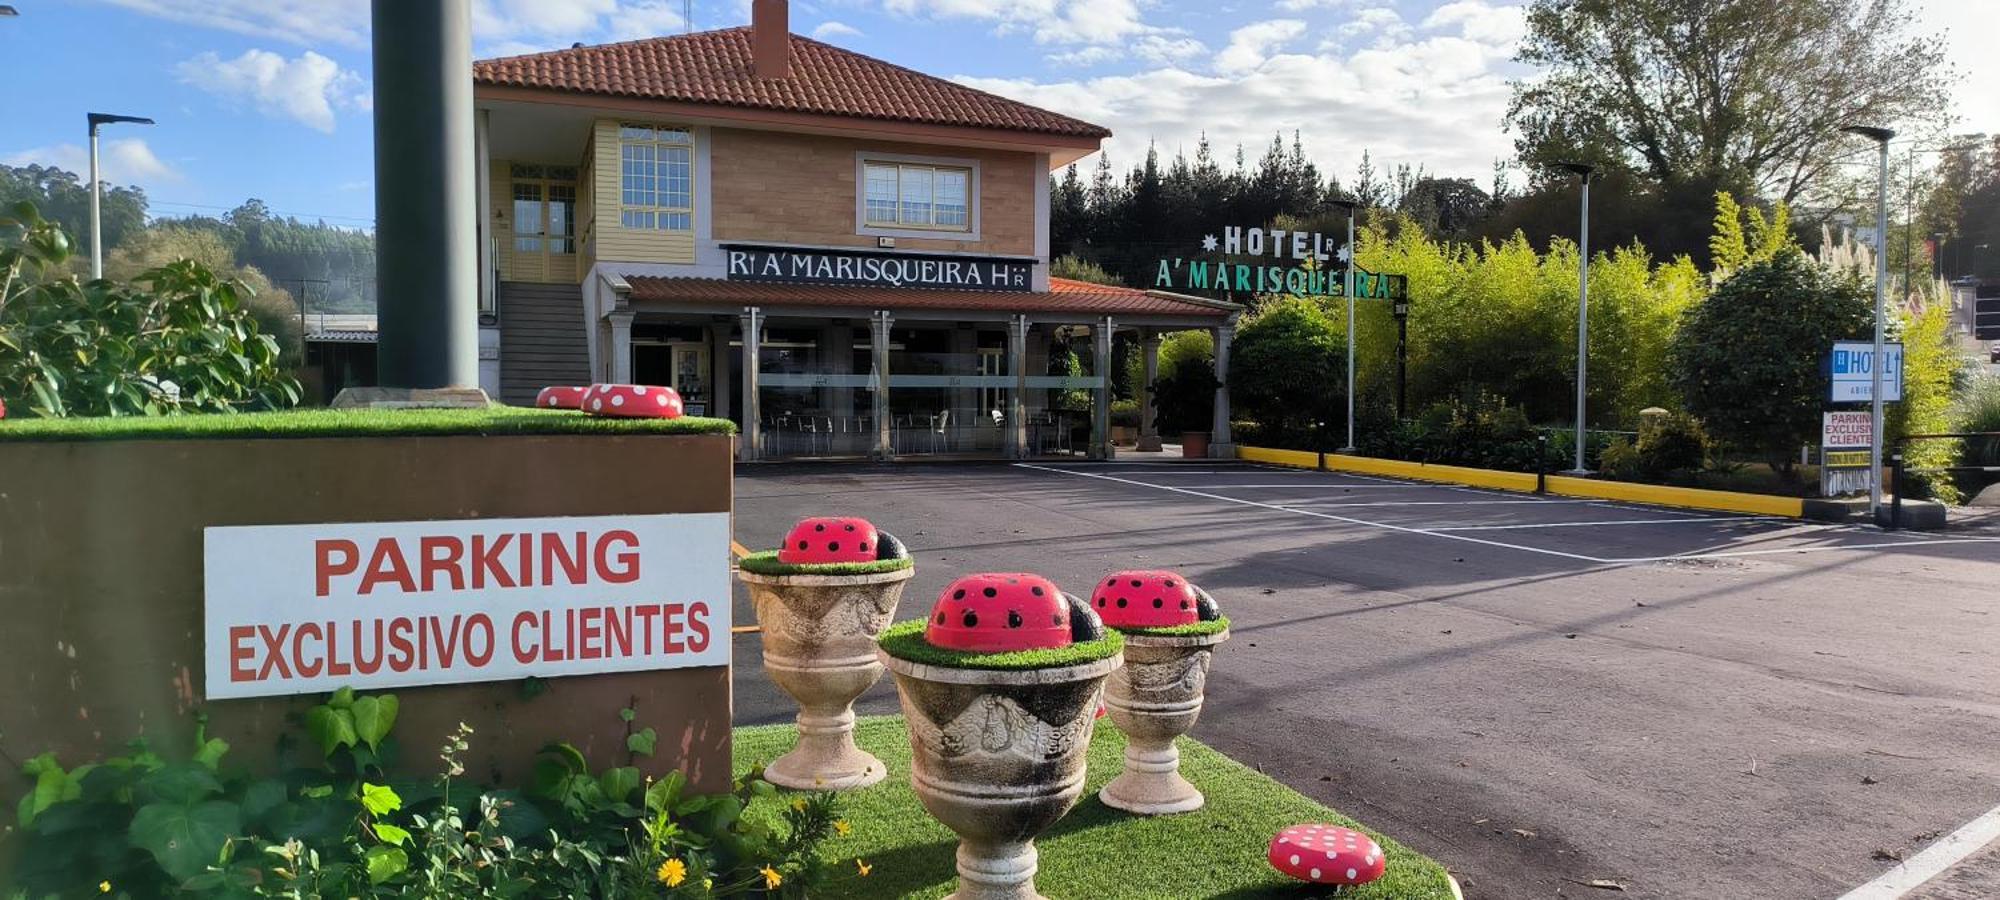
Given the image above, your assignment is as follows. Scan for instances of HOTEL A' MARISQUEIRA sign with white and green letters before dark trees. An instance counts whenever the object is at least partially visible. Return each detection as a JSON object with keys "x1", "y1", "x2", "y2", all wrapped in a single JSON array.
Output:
[{"x1": 1152, "y1": 226, "x2": 1410, "y2": 306}]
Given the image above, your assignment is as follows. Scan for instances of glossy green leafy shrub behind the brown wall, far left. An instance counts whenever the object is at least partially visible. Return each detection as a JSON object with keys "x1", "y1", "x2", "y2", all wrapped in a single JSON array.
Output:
[{"x1": 0, "y1": 202, "x2": 300, "y2": 416}]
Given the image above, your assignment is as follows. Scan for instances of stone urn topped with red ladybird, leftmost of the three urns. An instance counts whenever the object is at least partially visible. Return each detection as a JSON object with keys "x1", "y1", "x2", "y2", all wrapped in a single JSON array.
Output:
[{"x1": 736, "y1": 518, "x2": 916, "y2": 790}]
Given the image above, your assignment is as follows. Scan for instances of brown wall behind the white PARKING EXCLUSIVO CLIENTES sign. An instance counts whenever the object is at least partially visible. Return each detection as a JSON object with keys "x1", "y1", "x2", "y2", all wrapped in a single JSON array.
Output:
[{"x1": 0, "y1": 436, "x2": 732, "y2": 816}]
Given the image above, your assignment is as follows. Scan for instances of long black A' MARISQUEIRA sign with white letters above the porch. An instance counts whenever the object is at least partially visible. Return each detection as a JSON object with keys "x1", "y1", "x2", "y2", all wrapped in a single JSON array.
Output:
[{"x1": 722, "y1": 244, "x2": 1034, "y2": 292}]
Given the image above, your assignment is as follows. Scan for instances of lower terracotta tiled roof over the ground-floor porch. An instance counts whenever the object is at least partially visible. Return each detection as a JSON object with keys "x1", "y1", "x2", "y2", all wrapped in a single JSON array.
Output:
[{"x1": 626, "y1": 276, "x2": 1238, "y2": 318}]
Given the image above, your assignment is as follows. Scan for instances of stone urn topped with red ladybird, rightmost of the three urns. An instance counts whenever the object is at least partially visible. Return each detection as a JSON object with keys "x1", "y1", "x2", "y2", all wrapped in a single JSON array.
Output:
[{"x1": 1090, "y1": 572, "x2": 1230, "y2": 816}]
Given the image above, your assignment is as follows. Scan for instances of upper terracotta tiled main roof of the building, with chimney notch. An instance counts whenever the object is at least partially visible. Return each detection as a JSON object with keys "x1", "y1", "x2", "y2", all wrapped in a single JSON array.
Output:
[{"x1": 472, "y1": 28, "x2": 1112, "y2": 138}]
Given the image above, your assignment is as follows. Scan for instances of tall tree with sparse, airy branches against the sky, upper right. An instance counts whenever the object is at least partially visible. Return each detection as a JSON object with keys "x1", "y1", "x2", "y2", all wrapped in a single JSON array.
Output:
[{"x1": 1506, "y1": 0, "x2": 1950, "y2": 200}]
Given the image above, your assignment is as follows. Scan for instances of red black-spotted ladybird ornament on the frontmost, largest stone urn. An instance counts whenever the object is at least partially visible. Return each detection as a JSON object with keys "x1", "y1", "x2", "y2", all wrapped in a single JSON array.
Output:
[{"x1": 924, "y1": 572, "x2": 1104, "y2": 654}]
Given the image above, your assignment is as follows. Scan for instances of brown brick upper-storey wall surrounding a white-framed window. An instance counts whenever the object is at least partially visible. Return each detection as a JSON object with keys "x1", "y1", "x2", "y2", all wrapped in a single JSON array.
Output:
[{"x1": 708, "y1": 128, "x2": 1036, "y2": 256}]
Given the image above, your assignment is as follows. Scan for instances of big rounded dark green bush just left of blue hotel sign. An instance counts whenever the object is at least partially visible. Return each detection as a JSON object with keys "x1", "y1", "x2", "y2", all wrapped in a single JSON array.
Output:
[{"x1": 1668, "y1": 248, "x2": 1874, "y2": 476}]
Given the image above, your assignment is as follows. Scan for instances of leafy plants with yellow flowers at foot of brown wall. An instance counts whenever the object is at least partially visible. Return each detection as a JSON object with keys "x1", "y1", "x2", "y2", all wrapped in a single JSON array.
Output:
[{"x1": 14, "y1": 690, "x2": 846, "y2": 900}]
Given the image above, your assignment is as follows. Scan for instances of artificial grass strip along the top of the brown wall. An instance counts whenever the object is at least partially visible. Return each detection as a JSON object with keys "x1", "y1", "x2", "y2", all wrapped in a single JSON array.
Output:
[{"x1": 0, "y1": 406, "x2": 736, "y2": 442}]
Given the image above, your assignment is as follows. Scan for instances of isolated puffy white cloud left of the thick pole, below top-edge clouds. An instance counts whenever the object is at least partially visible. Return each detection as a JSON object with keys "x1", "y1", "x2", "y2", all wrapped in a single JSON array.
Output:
[{"x1": 174, "y1": 50, "x2": 370, "y2": 134}]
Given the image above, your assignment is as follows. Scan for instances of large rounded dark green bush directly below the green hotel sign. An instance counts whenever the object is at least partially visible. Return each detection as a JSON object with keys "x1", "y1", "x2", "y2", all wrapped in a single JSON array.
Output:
[{"x1": 1230, "y1": 298, "x2": 1346, "y2": 442}]
